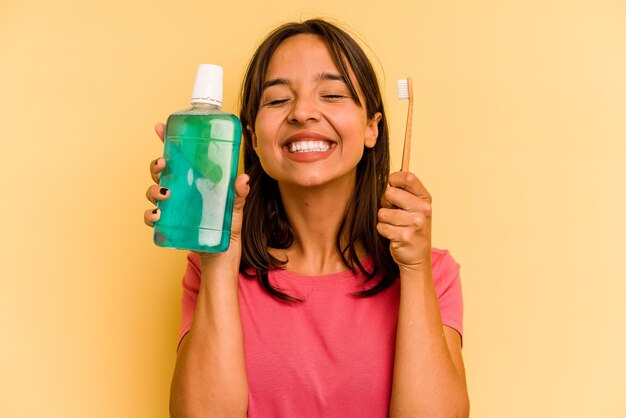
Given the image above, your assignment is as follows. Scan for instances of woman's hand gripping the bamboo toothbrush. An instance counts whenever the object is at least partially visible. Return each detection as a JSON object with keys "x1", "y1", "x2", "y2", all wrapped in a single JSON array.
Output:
[{"x1": 376, "y1": 171, "x2": 432, "y2": 270}]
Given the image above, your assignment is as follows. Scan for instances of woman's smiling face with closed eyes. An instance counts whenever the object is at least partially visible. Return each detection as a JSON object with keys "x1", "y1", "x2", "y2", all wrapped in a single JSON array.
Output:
[{"x1": 252, "y1": 35, "x2": 380, "y2": 186}]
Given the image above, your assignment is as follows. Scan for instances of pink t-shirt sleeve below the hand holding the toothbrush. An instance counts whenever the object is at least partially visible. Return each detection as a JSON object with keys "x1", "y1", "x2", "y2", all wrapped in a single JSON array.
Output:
[{"x1": 433, "y1": 250, "x2": 463, "y2": 338}]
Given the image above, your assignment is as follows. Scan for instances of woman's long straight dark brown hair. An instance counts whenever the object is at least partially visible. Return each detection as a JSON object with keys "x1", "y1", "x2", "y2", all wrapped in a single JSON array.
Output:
[{"x1": 240, "y1": 19, "x2": 399, "y2": 302}]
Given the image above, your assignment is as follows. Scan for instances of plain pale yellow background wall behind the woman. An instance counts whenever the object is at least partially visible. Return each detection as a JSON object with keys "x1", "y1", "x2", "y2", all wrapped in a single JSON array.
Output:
[{"x1": 0, "y1": 0, "x2": 626, "y2": 418}]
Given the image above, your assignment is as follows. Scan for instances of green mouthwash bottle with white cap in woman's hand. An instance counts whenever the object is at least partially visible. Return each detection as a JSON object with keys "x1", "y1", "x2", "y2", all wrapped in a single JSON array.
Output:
[{"x1": 154, "y1": 64, "x2": 241, "y2": 252}]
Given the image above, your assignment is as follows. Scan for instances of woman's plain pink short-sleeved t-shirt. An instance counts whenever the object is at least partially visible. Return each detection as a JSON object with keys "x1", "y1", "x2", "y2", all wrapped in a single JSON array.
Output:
[{"x1": 179, "y1": 249, "x2": 463, "y2": 418}]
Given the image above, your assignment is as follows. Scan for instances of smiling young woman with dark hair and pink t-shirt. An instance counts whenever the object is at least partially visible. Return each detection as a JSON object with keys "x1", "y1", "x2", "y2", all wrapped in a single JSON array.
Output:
[{"x1": 144, "y1": 19, "x2": 469, "y2": 417}]
